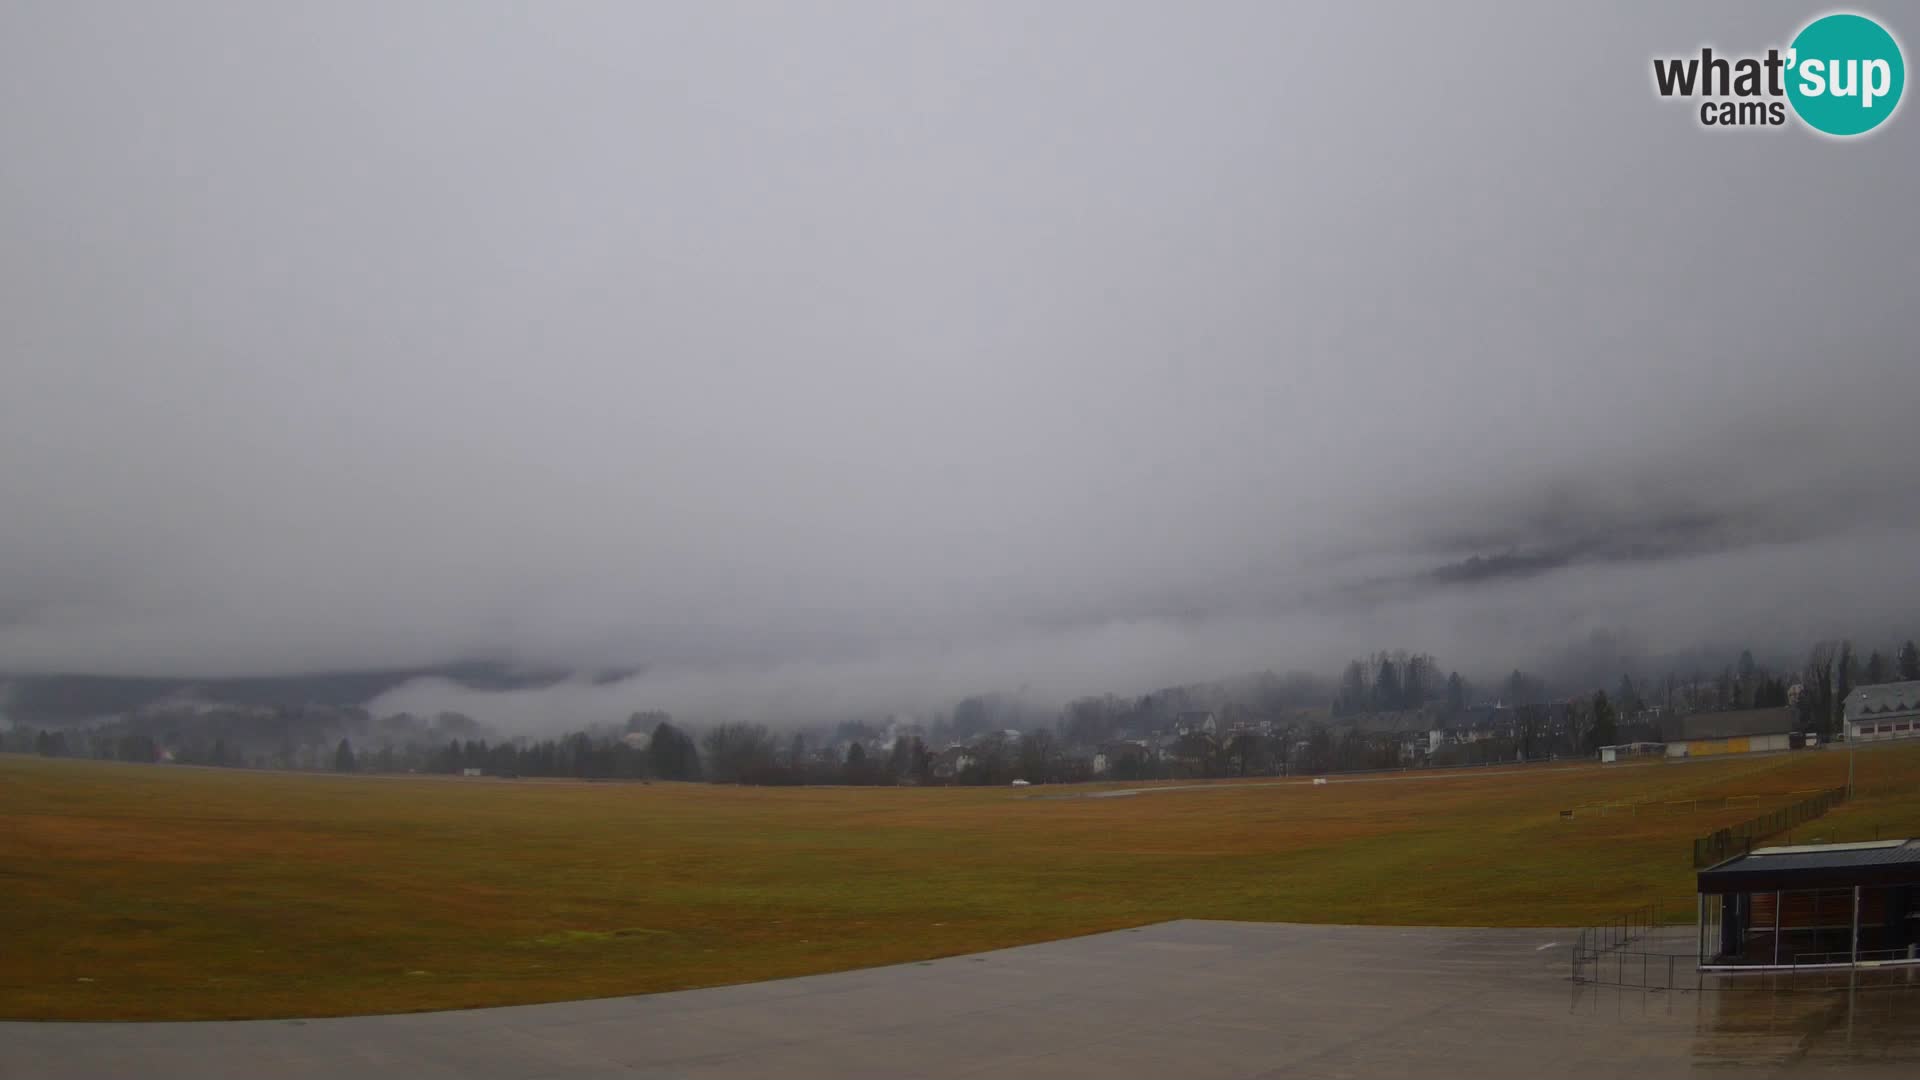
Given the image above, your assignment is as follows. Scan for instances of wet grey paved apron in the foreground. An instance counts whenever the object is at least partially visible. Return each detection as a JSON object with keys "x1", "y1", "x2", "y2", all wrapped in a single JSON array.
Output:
[{"x1": 0, "y1": 920, "x2": 1920, "y2": 1080}]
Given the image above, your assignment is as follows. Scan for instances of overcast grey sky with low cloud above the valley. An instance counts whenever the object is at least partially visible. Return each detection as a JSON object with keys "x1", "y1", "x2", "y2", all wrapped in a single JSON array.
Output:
[{"x1": 0, "y1": 0, "x2": 1920, "y2": 715}]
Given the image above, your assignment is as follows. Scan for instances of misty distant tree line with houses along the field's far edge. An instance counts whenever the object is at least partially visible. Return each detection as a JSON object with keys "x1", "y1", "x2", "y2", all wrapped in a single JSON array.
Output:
[{"x1": 15, "y1": 640, "x2": 1920, "y2": 784}]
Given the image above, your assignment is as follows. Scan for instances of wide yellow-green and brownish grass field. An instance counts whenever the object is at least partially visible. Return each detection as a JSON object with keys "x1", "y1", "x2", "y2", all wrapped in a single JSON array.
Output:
[{"x1": 0, "y1": 748, "x2": 1920, "y2": 1019}]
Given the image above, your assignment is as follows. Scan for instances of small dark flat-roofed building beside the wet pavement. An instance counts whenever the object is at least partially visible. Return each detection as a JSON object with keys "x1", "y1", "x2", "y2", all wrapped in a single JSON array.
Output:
[{"x1": 1699, "y1": 840, "x2": 1920, "y2": 970}]
